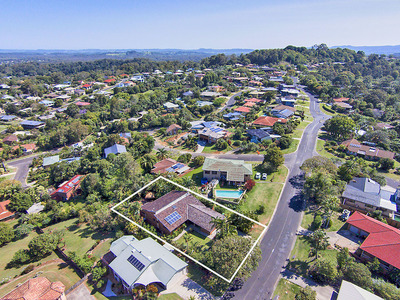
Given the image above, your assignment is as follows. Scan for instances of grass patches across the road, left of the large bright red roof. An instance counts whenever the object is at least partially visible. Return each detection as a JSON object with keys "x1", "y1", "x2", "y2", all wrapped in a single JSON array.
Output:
[{"x1": 288, "y1": 236, "x2": 337, "y2": 277}]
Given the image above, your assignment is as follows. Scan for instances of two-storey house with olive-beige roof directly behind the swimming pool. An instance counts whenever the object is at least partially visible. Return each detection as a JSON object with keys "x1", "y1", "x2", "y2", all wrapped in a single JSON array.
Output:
[{"x1": 203, "y1": 157, "x2": 253, "y2": 185}]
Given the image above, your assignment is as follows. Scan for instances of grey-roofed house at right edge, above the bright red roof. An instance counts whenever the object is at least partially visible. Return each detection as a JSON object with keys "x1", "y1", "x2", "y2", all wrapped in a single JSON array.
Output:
[{"x1": 341, "y1": 177, "x2": 397, "y2": 219}]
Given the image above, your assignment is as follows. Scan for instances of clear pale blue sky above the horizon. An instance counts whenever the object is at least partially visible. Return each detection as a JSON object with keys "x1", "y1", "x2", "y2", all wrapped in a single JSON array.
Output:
[{"x1": 0, "y1": 0, "x2": 400, "y2": 49}]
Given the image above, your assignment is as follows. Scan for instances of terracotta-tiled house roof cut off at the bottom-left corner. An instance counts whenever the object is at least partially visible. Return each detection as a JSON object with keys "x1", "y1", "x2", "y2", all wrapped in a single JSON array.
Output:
[{"x1": 1, "y1": 277, "x2": 67, "y2": 300}]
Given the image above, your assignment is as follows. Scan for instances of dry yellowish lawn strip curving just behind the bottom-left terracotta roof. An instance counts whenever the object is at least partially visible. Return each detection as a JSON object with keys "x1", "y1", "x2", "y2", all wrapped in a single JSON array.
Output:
[{"x1": 0, "y1": 259, "x2": 80, "y2": 296}]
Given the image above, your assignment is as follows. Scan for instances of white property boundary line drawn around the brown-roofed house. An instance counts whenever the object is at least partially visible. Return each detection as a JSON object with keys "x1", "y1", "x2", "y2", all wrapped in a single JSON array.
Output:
[{"x1": 111, "y1": 176, "x2": 267, "y2": 283}]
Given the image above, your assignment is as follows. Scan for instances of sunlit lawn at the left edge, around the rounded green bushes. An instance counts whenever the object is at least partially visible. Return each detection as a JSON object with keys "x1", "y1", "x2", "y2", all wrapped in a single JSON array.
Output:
[{"x1": 0, "y1": 231, "x2": 57, "y2": 281}]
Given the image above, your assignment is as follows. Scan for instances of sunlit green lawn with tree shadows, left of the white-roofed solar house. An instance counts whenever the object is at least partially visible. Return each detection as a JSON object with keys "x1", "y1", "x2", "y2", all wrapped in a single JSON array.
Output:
[{"x1": 44, "y1": 219, "x2": 113, "y2": 255}]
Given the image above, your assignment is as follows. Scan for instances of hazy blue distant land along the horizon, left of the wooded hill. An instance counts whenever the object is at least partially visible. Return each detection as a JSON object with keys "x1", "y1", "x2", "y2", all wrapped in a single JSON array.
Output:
[{"x1": 0, "y1": 49, "x2": 253, "y2": 62}]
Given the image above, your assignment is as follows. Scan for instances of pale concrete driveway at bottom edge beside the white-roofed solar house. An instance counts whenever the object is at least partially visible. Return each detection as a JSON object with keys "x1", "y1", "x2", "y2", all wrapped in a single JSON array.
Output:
[{"x1": 160, "y1": 275, "x2": 215, "y2": 300}]
